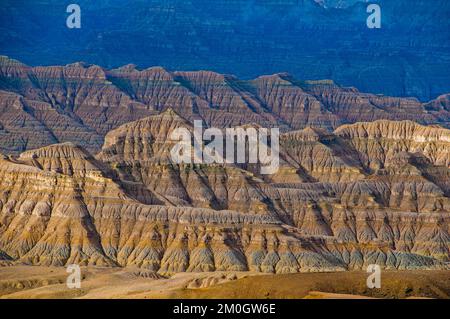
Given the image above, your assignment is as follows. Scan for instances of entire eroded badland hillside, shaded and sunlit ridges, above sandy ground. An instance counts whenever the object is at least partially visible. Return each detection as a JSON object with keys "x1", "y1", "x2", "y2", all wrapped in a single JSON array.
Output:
[{"x1": 0, "y1": 99, "x2": 450, "y2": 275}]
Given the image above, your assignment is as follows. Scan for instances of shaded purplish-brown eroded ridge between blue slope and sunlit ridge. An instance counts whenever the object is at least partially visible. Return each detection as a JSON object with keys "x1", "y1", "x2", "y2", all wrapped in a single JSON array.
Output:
[{"x1": 0, "y1": 57, "x2": 450, "y2": 154}]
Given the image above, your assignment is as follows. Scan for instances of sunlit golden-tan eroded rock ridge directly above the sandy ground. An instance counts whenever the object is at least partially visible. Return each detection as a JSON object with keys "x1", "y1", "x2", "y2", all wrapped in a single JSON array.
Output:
[{"x1": 0, "y1": 109, "x2": 450, "y2": 275}]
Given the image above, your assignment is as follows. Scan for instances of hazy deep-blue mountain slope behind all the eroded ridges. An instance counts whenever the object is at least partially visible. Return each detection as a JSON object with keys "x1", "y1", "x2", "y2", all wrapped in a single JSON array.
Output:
[{"x1": 0, "y1": 0, "x2": 450, "y2": 101}]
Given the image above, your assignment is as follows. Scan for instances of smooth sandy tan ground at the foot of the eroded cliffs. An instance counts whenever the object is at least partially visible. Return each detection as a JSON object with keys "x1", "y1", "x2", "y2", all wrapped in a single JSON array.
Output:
[{"x1": 0, "y1": 266, "x2": 450, "y2": 299}]
